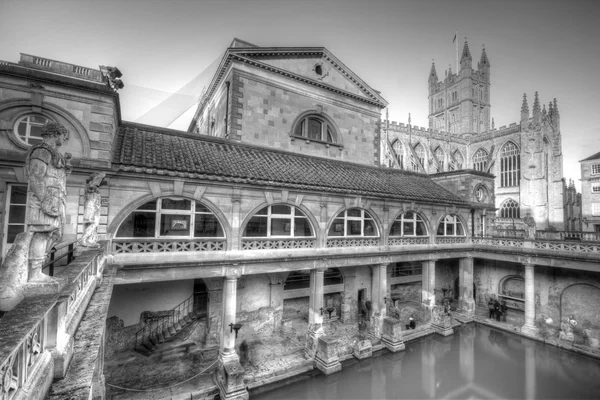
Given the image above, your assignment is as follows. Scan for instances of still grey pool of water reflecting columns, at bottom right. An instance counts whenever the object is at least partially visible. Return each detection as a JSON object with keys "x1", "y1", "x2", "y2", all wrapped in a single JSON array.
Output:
[{"x1": 251, "y1": 324, "x2": 600, "y2": 400}]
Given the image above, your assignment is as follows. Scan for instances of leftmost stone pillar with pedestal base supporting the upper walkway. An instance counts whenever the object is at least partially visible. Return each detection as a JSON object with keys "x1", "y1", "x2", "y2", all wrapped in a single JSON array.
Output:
[{"x1": 216, "y1": 274, "x2": 249, "y2": 400}]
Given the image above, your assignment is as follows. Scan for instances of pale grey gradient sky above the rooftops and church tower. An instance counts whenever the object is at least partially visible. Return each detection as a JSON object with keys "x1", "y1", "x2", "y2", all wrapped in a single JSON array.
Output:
[{"x1": 0, "y1": 0, "x2": 600, "y2": 190}]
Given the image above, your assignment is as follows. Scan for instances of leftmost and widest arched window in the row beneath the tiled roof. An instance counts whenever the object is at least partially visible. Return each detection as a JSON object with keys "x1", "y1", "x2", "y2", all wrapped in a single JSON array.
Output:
[{"x1": 116, "y1": 197, "x2": 225, "y2": 238}]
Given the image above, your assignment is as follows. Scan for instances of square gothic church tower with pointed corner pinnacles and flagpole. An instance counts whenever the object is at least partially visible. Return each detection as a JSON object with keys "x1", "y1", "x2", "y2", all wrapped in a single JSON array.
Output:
[{"x1": 429, "y1": 41, "x2": 490, "y2": 135}]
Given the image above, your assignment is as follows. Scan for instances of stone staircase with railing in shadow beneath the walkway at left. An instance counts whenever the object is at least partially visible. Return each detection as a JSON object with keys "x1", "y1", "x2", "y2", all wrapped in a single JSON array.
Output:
[{"x1": 134, "y1": 296, "x2": 200, "y2": 356}]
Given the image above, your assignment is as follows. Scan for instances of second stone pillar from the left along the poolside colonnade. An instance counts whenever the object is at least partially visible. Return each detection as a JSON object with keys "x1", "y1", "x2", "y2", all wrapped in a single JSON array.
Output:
[{"x1": 304, "y1": 268, "x2": 326, "y2": 358}]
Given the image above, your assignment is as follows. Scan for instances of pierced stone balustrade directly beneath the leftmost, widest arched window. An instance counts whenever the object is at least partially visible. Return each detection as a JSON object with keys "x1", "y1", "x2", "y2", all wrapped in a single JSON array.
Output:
[{"x1": 112, "y1": 238, "x2": 226, "y2": 254}]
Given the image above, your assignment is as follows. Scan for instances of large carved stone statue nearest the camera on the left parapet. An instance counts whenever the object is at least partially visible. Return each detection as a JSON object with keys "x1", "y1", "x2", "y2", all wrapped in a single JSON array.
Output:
[{"x1": 0, "y1": 122, "x2": 71, "y2": 311}]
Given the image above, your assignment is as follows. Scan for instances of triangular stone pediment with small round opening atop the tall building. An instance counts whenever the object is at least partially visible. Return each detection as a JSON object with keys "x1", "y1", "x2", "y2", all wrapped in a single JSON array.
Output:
[{"x1": 230, "y1": 47, "x2": 387, "y2": 104}]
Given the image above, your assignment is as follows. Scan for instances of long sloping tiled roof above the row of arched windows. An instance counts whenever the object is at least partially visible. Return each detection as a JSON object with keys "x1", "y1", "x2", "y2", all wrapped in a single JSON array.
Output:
[{"x1": 113, "y1": 123, "x2": 468, "y2": 206}]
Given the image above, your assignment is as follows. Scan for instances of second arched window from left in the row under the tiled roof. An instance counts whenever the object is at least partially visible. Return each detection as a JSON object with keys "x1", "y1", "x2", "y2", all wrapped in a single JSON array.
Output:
[{"x1": 244, "y1": 204, "x2": 313, "y2": 237}]
